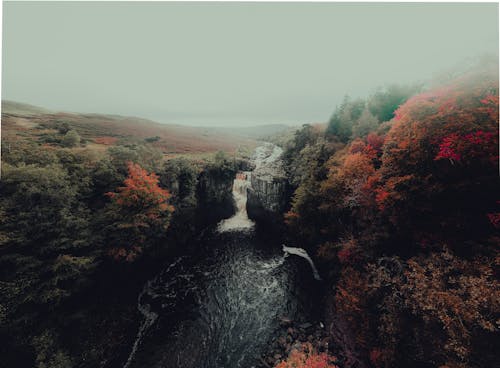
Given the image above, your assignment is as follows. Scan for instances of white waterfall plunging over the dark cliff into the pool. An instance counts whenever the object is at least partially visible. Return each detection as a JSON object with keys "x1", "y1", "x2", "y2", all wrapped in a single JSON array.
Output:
[{"x1": 217, "y1": 171, "x2": 254, "y2": 233}]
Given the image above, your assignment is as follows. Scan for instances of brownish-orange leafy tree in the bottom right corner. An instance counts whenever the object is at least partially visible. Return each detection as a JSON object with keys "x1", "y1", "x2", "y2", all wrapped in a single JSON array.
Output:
[{"x1": 404, "y1": 249, "x2": 500, "y2": 367}]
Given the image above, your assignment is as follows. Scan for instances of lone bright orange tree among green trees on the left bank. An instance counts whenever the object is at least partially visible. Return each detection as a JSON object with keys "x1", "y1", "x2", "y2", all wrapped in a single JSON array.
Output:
[{"x1": 106, "y1": 162, "x2": 174, "y2": 262}]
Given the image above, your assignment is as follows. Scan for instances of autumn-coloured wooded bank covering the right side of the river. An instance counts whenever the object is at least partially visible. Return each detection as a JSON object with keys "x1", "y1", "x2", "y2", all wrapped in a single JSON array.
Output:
[{"x1": 284, "y1": 66, "x2": 500, "y2": 367}]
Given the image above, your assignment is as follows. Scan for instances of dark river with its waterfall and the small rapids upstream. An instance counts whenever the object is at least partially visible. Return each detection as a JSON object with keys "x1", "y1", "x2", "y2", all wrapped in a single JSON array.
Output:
[{"x1": 124, "y1": 144, "x2": 316, "y2": 368}]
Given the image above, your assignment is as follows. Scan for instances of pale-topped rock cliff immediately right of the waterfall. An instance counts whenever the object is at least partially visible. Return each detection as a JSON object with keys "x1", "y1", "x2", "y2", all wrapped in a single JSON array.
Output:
[{"x1": 247, "y1": 144, "x2": 289, "y2": 223}]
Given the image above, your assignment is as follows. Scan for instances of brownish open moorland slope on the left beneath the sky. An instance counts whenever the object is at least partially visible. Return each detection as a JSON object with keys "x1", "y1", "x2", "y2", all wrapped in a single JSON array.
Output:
[{"x1": 2, "y1": 101, "x2": 255, "y2": 154}]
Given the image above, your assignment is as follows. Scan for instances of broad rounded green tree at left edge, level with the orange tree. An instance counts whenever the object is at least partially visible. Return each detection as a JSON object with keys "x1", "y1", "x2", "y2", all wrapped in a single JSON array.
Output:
[{"x1": 0, "y1": 164, "x2": 87, "y2": 254}]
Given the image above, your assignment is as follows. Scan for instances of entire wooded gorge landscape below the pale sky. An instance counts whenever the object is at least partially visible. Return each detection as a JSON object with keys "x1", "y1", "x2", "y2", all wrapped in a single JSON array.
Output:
[{"x1": 0, "y1": 57, "x2": 500, "y2": 368}]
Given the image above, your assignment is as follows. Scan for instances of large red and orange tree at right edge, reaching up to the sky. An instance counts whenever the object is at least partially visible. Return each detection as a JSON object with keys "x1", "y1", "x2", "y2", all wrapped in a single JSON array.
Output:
[{"x1": 374, "y1": 72, "x2": 498, "y2": 243}]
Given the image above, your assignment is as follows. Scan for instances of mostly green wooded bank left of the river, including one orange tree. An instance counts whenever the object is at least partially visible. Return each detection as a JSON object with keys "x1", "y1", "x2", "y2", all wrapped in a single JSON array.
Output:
[{"x1": 0, "y1": 111, "x2": 246, "y2": 368}]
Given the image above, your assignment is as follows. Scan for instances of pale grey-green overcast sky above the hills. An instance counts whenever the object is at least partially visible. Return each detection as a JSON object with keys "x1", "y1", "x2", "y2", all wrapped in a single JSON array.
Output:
[{"x1": 2, "y1": 1, "x2": 498, "y2": 125}]
